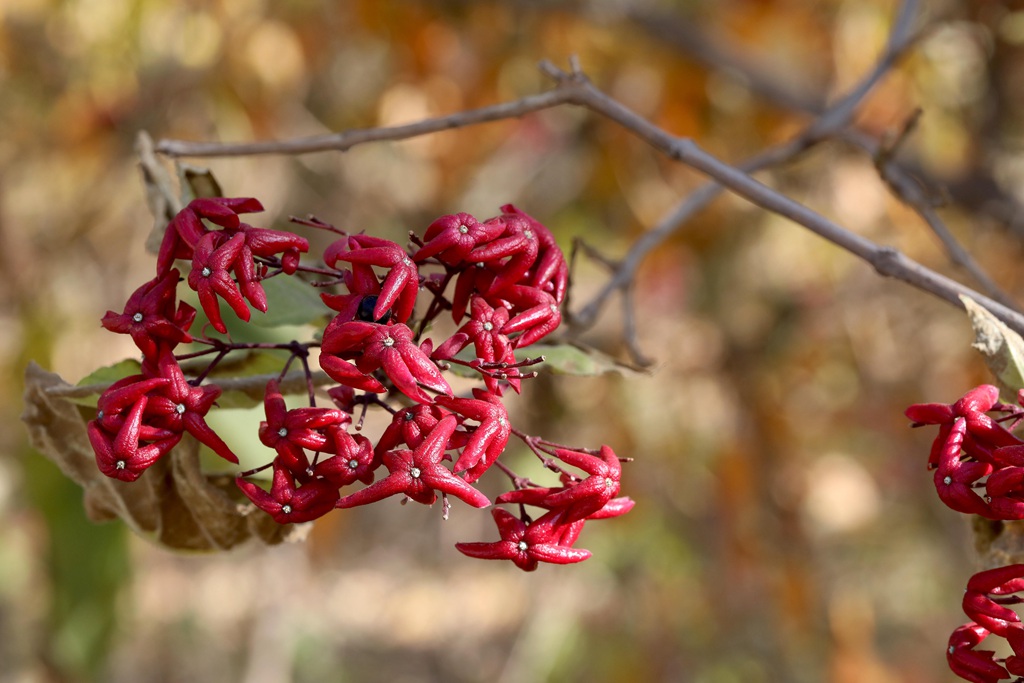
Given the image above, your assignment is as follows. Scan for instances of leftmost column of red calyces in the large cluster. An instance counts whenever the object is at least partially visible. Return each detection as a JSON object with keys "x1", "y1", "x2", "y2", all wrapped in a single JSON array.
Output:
[{"x1": 88, "y1": 199, "x2": 308, "y2": 481}]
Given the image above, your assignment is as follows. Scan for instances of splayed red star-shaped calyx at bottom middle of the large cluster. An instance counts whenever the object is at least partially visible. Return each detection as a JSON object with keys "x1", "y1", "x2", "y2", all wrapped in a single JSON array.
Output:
[{"x1": 337, "y1": 415, "x2": 490, "y2": 508}]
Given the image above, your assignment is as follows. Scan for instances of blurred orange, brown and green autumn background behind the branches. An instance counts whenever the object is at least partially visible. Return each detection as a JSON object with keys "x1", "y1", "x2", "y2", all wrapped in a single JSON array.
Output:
[{"x1": 0, "y1": 0, "x2": 1024, "y2": 683}]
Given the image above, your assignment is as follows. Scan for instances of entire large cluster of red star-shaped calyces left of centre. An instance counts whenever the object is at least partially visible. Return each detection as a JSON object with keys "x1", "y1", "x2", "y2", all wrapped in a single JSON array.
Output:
[{"x1": 89, "y1": 199, "x2": 633, "y2": 570}]
